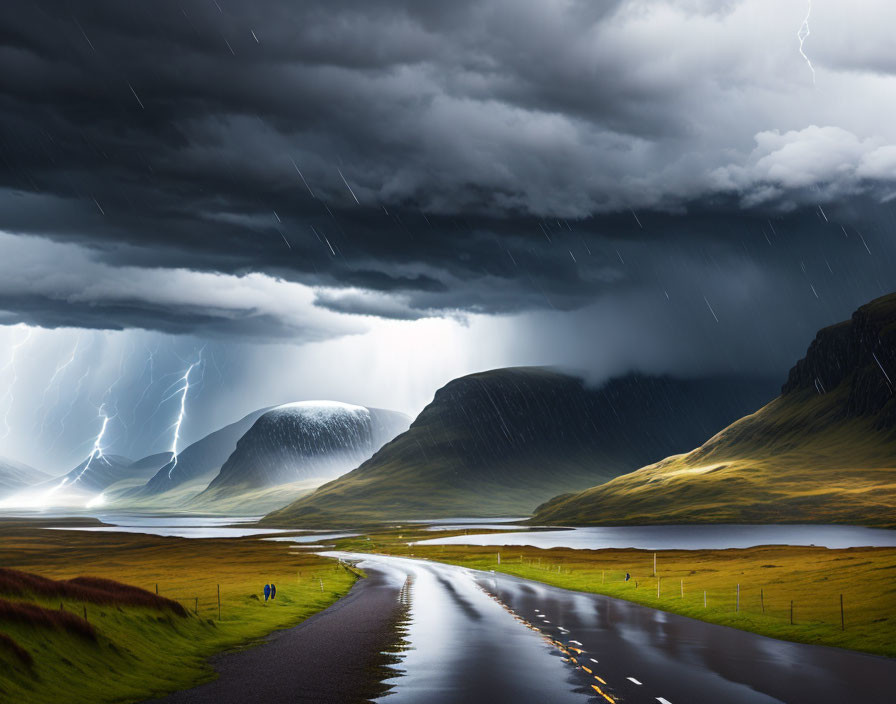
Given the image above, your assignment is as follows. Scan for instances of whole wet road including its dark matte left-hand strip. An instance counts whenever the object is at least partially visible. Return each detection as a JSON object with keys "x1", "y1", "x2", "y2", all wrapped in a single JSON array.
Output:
[{"x1": 149, "y1": 553, "x2": 896, "y2": 704}]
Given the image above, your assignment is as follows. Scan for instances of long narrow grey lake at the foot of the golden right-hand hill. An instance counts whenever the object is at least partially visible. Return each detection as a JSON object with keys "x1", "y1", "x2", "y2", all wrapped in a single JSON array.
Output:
[{"x1": 417, "y1": 524, "x2": 896, "y2": 550}]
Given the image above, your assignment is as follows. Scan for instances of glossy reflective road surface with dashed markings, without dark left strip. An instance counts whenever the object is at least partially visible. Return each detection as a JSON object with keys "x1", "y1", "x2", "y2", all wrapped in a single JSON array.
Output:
[{"x1": 325, "y1": 553, "x2": 896, "y2": 704}]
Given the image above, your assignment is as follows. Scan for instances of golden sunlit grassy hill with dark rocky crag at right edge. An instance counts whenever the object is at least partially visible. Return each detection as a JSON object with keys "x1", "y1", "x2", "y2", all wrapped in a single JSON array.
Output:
[{"x1": 533, "y1": 294, "x2": 896, "y2": 527}]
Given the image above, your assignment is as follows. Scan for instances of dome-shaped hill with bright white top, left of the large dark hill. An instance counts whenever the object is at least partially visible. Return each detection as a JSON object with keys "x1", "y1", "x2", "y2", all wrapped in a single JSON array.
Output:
[{"x1": 196, "y1": 401, "x2": 410, "y2": 505}]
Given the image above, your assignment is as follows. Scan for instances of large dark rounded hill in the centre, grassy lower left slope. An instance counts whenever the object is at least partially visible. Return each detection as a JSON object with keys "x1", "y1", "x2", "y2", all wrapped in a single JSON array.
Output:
[{"x1": 265, "y1": 368, "x2": 774, "y2": 525}]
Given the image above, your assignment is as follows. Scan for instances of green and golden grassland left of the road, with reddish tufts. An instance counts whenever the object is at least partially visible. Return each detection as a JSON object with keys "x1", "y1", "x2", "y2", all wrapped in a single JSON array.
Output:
[{"x1": 0, "y1": 520, "x2": 356, "y2": 704}]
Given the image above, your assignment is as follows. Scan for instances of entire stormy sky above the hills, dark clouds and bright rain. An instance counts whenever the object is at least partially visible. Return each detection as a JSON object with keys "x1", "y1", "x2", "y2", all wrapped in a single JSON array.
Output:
[{"x1": 0, "y1": 0, "x2": 896, "y2": 470}]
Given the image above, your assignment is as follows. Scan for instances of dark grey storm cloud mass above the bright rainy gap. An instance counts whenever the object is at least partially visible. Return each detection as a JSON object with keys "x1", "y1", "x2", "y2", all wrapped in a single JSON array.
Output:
[{"x1": 0, "y1": 0, "x2": 896, "y2": 339}]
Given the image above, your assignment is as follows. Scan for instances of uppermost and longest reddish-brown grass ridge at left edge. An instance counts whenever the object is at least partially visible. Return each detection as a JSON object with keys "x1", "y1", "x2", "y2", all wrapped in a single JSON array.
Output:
[{"x1": 0, "y1": 567, "x2": 187, "y2": 616}]
